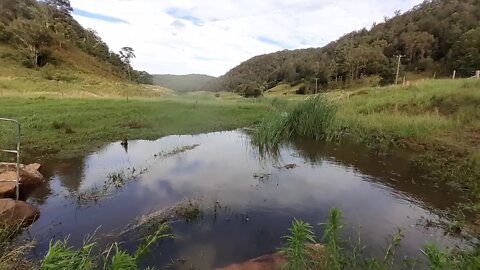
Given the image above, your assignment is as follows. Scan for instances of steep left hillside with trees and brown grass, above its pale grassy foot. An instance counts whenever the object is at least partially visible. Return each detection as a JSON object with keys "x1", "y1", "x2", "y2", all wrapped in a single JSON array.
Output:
[{"x1": 0, "y1": 0, "x2": 151, "y2": 83}]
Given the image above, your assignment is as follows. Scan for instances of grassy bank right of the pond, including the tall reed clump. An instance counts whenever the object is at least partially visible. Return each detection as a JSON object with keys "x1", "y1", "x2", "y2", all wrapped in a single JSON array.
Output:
[{"x1": 255, "y1": 80, "x2": 480, "y2": 223}]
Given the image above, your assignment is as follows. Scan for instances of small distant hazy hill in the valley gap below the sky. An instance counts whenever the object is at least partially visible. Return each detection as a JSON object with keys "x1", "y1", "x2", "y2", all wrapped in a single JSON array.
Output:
[{"x1": 152, "y1": 74, "x2": 216, "y2": 92}]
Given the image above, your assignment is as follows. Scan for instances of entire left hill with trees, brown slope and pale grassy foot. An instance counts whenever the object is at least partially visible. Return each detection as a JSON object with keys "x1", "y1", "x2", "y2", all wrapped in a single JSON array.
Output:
[{"x1": 0, "y1": 0, "x2": 152, "y2": 95}]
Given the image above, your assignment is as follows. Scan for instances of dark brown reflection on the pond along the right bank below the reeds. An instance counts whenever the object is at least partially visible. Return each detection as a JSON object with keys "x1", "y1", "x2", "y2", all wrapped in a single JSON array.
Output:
[{"x1": 290, "y1": 139, "x2": 459, "y2": 211}]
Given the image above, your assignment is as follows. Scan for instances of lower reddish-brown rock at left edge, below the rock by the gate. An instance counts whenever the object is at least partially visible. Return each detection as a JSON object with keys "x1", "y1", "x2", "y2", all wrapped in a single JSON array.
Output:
[{"x1": 0, "y1": 199, "x2": 40, "y2": 226}]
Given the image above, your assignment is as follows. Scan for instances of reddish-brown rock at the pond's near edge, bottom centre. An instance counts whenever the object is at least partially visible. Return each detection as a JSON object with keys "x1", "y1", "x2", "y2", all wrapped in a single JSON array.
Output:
[{"x1": 217, "y1": 252, "x2": 287, "y2": 270}]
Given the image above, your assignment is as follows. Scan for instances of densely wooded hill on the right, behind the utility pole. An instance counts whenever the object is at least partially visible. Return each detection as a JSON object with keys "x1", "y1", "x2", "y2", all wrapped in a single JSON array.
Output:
[{"x1": 210, "y1": 0, "x2": 480, "y2": 95}]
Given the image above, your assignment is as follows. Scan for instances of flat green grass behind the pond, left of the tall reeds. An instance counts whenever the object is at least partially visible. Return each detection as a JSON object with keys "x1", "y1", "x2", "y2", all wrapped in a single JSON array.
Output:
[{"x1": 0, "y1": 97, "x2": 266, "y2": 158}]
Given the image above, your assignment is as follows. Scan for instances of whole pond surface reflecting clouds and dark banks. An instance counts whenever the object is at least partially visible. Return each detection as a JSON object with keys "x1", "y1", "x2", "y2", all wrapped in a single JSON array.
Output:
[{"x1": 22, "y1": 130, "x2": 468, "y2": 269}]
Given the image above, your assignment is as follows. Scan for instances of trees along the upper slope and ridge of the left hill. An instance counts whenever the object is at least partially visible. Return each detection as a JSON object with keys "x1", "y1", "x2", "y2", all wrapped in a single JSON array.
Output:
[{"x1": 0, "y1": 0, "x2": 152, "y2": 84}]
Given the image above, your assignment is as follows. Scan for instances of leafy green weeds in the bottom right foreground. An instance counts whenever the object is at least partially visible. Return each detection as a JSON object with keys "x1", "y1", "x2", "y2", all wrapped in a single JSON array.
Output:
[{"x1": 281, "y1": 208, "x2": 480, "y2": 270}]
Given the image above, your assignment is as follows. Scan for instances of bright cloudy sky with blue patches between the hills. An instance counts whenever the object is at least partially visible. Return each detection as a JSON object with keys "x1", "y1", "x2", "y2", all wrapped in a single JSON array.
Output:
[{"x1": 70, "y1": 0, "x2": 422, "y2": 76}]
